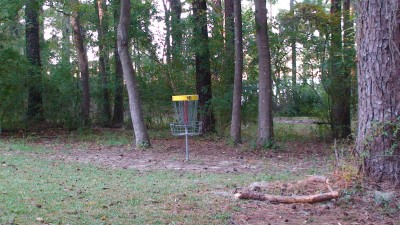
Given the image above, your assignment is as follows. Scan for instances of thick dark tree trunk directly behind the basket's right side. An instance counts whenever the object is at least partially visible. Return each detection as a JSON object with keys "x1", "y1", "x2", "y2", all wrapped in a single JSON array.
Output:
[{"x1": 192, "y1": 0, "x2": 214, "y2": 133}]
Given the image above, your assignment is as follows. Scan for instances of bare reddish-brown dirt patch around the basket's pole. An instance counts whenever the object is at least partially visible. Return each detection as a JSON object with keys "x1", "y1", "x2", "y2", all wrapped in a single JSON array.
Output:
[{"x1": 41, "y1": 139, "x2": 266, "y2": 173}]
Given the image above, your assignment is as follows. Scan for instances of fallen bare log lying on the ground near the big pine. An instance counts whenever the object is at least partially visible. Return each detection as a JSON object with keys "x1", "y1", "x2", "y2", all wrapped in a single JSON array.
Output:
[{"x1": 235, "y1": 191, "x2": 340, "y2": 204}]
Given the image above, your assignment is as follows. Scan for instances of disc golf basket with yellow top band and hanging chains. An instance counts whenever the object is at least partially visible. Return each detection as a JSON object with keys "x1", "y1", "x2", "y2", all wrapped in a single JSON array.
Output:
[{"x1": 170, "y1": 95, "x2": 201, "y2": 161}]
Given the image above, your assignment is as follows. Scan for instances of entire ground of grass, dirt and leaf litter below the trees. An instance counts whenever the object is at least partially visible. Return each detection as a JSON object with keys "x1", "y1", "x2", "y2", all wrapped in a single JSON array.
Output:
[{"x1": 0, "y1": 124, "x2": 400, "y2": 225}]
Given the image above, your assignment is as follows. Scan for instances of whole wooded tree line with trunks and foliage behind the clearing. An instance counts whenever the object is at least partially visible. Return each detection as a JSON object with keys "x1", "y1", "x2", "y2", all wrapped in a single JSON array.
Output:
[{"x1": 0, "y1": 0, "x2": 400, "y2": 185}]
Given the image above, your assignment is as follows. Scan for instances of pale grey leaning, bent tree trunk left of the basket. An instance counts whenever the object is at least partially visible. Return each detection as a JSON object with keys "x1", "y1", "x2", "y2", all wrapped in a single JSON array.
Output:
[{"x1": 118, "y1": 0, "x2": 150, "y2": 147}]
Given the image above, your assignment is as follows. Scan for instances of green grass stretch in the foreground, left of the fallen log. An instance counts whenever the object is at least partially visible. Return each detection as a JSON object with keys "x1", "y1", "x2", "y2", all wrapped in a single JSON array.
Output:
[{"x1": 0, "y1": 143, "x2": 287, "y2": 224}]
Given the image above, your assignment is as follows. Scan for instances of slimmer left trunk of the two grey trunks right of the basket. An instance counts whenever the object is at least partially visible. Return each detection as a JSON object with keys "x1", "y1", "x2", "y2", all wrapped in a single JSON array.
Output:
[{"x1": 231, "y1": 0, "x2": 243, "y2": 144}]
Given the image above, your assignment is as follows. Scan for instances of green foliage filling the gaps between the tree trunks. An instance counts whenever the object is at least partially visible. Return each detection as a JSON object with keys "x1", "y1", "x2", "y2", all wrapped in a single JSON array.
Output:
[{"x1": 0, "y1": 0, "x2": 356, "y2": 143}]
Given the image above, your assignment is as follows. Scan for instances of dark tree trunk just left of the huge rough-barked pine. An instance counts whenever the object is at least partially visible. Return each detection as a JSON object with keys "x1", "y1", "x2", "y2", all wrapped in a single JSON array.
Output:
[{"x1": 328, "y1": 0, "x2": 351, "y2": 139}]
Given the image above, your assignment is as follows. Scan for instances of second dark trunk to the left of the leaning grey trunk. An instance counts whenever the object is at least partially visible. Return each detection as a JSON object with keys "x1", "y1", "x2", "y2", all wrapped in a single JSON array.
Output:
[{"x1": 95, "y1": 0, "x2": 111, "y2": 125}]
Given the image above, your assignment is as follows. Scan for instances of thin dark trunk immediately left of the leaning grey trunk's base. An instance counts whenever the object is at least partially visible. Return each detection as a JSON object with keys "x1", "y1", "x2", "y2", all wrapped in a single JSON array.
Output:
[{"x1": 113, "y1": 0, "x2": 124, "y2": 125}]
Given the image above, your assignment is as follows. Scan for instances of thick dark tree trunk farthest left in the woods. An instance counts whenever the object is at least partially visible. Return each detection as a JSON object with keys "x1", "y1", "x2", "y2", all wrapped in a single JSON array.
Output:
[{"x1": 25, "y1": 0, "x2": 44, "y2": 122}]
